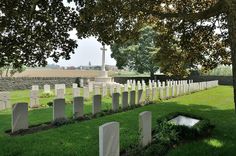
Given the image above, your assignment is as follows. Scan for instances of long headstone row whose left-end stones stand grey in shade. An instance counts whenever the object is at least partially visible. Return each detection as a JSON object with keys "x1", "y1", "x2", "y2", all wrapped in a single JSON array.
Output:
[{"x1": 9, "y1": 81, "x2": 218, "y2": 132}]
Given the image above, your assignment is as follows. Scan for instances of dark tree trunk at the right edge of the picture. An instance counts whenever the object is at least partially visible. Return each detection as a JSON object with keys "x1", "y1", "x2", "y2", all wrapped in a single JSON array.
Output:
[{"x1": 227, "y1": 0, "x2": 236, "y2": 113}]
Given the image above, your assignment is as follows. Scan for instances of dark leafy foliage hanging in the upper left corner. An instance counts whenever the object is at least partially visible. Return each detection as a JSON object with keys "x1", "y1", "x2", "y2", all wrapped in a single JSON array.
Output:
[{"x1": 0, "y1": 0, "x2": 77, "y2": 68}]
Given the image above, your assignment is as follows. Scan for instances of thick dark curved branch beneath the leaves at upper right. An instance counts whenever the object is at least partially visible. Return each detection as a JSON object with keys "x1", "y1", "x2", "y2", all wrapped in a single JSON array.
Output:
[{"x1": 149, "y1": 0, "x2": 225, "y2": 21}]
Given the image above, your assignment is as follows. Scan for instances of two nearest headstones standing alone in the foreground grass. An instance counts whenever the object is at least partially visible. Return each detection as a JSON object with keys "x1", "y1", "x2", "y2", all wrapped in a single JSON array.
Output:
[{"x1": 99, "y1": 111, "x2": 152, "y2": 156}]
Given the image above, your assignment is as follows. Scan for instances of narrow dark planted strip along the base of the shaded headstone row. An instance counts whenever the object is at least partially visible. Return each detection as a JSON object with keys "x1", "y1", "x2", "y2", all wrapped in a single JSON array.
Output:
[{"x1": 5, "y1": 103, "x2": 154, "y2": 136}]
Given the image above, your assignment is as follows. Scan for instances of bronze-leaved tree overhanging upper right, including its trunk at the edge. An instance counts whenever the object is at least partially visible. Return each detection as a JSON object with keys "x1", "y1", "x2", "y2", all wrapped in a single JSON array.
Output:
[{"x1": 72, "y1": 0, "x2": 236, "y2": 112}]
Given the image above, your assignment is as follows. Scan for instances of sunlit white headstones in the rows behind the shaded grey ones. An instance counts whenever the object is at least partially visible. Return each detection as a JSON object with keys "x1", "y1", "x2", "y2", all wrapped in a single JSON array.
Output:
[{"x1": 0, "y1": 80, "x2": 218, "y2": 110}]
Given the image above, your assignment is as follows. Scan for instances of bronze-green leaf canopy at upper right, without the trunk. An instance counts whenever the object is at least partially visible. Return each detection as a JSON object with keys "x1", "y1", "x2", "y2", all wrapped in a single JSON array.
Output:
[{"x1": 73, "y1": 0, "x2": 231, "y2": 75}]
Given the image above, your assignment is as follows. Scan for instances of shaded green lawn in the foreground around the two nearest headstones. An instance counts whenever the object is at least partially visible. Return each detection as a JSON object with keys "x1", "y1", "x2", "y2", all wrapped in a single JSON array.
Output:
[{"x1": 0, "y1": 101, "x2": 236, "y2": 156}]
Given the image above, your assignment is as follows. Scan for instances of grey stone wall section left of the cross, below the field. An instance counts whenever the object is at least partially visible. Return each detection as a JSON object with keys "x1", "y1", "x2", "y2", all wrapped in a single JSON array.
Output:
[{"x1": 0, "y1": 77, "x2": 91, "y2": 91}]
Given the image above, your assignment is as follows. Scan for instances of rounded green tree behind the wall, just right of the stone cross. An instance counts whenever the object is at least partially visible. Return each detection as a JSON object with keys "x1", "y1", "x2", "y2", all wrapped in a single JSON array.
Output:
[{"x1": 111, "y1": 26, "x2": 159, "y2": 78}]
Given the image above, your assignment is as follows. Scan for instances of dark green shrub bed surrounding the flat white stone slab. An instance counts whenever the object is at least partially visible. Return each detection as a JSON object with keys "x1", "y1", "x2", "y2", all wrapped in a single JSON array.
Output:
[{"x1": 120, "y1": 112, "x2": 215, "y2": 156}]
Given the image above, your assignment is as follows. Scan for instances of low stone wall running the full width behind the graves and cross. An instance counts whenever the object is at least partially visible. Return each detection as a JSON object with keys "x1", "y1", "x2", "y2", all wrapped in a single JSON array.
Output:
[{"x1": 0, "y1": 75, "x2": 233, "y2": 91}]
